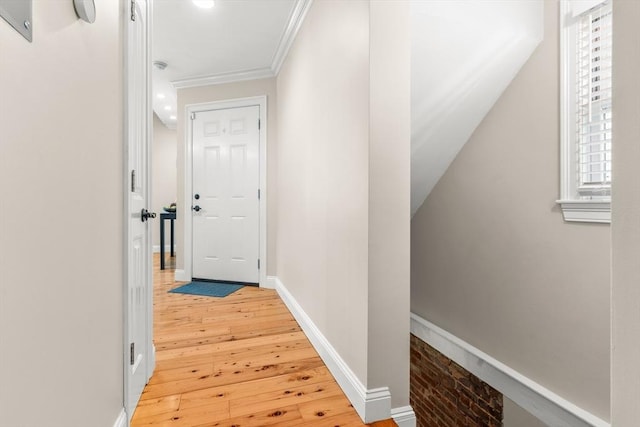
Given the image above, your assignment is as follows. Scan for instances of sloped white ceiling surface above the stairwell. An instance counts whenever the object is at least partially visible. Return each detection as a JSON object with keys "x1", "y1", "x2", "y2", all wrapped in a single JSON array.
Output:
[{"x1": 411, "y1": 0, "x2": 543, "y2": 216}]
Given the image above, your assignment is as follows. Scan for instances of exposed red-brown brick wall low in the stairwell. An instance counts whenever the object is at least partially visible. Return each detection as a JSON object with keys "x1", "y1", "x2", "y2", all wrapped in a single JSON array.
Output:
[{"x1": 410, "y1": 335, "x2": 502, "y2": 427}]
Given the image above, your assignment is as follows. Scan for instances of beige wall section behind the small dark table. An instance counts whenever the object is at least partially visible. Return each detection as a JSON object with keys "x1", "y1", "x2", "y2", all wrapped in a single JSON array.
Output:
[{"x1": 151, "y1": 114, "x2": 178, "y2": 251}]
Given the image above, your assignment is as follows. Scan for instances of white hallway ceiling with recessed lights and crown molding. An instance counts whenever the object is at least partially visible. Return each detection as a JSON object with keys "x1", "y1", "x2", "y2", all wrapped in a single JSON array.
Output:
[{"x1": 152, "y1": 0, "x2": 306, "y2": 129}]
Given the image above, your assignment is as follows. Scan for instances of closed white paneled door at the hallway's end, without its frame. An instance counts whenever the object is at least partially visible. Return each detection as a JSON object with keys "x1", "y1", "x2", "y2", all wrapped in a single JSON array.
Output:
[{"x1": 191, "y1": 106, "x2": 260, "y2": 283}]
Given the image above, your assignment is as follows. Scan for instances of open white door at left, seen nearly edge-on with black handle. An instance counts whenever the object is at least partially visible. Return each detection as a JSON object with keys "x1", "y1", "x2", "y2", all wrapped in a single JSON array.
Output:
[{"x1": 125, "y1": 0, "x2": 153, "y2": 419}]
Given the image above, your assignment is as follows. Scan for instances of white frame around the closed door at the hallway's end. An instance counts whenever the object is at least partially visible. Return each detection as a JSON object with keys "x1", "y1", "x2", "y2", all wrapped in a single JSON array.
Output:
[{"x1": 182, "y1": 95, "x2": 269, "y2": 288}]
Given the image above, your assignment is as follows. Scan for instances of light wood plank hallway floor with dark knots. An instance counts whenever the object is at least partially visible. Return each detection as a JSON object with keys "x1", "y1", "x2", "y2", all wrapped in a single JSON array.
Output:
[{"x1": 131, "y1": 254, "x2": 396, "y2": 427}]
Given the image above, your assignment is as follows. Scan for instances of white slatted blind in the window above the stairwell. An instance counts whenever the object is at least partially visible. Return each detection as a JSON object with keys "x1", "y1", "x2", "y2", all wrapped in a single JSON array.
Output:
[{"x1": 575, "y1": 1, "x2": 612, "y2": 198}]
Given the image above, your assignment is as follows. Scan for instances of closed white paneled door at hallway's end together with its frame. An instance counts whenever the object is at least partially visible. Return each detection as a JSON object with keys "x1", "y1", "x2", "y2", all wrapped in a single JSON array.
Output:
[{"x1": 176, "y1": 96, "x2": 267, "y2": 287}]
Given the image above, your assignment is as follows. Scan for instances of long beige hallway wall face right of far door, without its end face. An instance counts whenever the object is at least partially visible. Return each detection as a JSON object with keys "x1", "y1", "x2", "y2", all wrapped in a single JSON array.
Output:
[{"x1": 277, "y1": 1, "x2": 369, "y2": 385}]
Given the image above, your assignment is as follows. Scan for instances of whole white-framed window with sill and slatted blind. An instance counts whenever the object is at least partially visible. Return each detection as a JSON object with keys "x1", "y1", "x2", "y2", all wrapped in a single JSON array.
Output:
[{"x1": 558, "y1": 0, "x2": 612, "y2": 222}]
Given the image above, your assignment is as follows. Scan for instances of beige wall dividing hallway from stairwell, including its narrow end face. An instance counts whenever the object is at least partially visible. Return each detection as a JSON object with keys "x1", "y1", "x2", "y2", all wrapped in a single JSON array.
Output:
[{"x1": 277, "y1": 0, "x2": 410, "y2": 414}]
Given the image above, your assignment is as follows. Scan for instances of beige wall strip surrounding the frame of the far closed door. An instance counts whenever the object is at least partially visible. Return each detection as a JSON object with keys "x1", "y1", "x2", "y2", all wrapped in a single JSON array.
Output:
[{"x1": 176, "y1": 78, "x2": 278, "y2": 275}]
